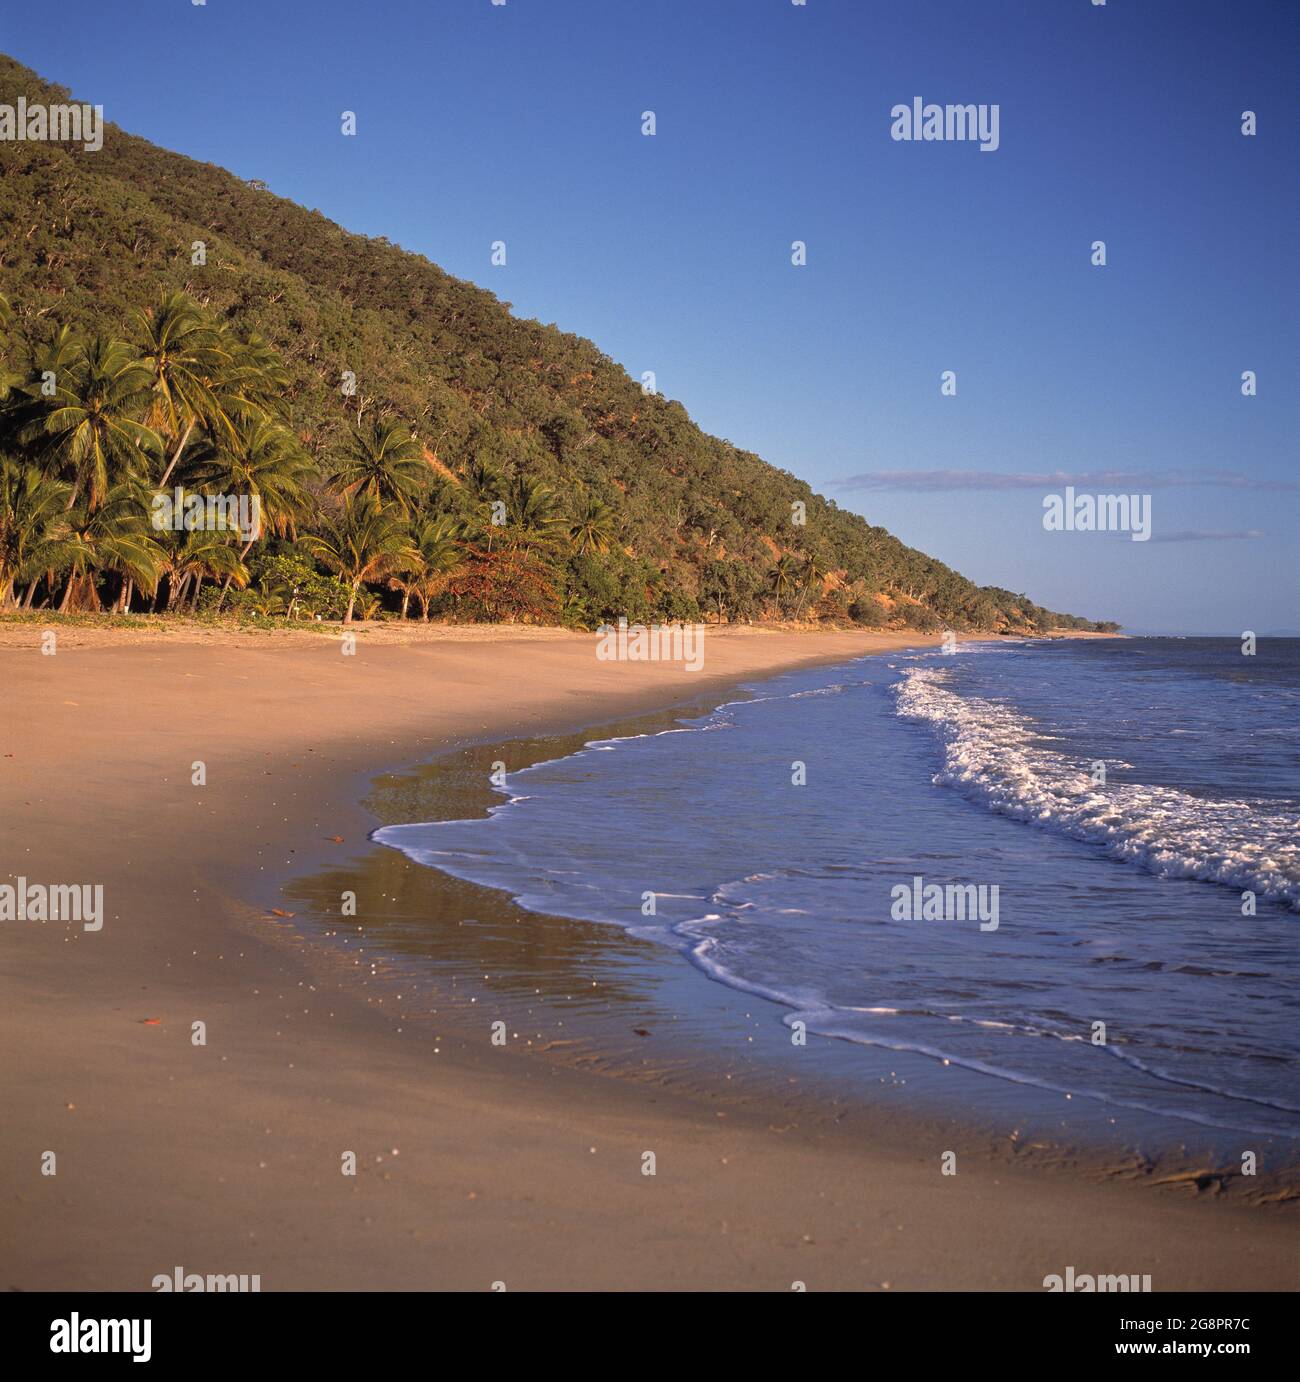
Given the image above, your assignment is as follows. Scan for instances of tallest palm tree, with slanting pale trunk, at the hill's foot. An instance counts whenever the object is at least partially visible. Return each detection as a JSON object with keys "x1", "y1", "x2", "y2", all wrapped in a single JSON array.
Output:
[{"x1": 135, "y1": 293, "x2": 231, "y2": 485}]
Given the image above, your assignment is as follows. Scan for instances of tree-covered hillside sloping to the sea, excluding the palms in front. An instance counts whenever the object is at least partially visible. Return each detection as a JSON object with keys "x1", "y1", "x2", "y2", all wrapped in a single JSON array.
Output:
[{"x1": 0, "y1": 55, "x2": 1116, "y2": 632}]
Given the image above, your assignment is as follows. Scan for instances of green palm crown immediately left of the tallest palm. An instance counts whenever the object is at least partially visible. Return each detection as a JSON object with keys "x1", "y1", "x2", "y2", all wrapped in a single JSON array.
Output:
[{"x1": 19, "y1": 336, "x2": 162, "y2": 511}]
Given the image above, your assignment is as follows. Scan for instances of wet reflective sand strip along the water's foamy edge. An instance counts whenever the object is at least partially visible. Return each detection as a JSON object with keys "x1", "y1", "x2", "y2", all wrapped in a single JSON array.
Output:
[{"x1": 314, "y1": 696, "x2": 1297, "y2": 1205}]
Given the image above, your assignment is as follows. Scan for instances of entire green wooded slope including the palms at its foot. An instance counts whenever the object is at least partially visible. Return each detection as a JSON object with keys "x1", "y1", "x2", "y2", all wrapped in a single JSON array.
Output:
[{"x1": 0, "y1": 55, "x2": 1116, "y2": 633}]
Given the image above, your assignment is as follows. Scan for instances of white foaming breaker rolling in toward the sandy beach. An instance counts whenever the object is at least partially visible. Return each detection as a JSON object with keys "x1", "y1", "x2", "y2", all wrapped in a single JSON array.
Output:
[{"x1": 892, "y1": 668, "x2": 1300, "y2": 911}]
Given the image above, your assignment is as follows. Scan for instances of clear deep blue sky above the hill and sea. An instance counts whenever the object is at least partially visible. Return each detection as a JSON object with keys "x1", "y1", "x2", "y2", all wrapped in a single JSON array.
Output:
[{"x1": 0, "y1": 0, "x2": 1300, "y2": 633}]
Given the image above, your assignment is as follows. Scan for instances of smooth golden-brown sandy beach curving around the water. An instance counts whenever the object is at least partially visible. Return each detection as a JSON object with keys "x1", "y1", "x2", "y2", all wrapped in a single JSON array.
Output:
[{"x1": 0, "y1": 625, "x2": 1297, "y2": 1291}]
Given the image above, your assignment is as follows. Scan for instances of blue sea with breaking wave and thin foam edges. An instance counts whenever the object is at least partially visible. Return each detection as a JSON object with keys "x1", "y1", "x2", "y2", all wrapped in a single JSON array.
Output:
[{"x1": 374, "y1": 638, "x2": 1300, "y2": 1151}]
